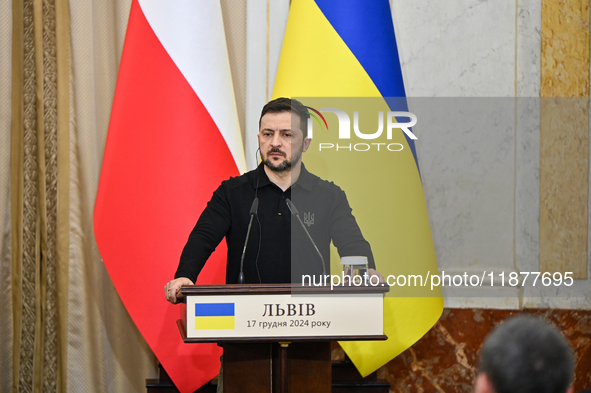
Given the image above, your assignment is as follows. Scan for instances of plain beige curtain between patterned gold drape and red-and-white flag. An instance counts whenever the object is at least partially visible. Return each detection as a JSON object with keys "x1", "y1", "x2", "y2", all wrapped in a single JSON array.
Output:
[{"x1": 67, "y1": 0, "x2": 157, "y2": 392}]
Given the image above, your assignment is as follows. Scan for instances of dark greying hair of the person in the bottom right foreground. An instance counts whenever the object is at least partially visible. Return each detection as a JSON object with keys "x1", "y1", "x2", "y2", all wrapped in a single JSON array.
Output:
[{"x1": 478, "y1": 315, "x2": 574, "y2": 393}]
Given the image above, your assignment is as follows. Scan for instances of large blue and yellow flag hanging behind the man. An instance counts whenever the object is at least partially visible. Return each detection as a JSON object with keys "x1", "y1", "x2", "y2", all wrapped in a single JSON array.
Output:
[{"x1": 273, "y1": 0, "x2": 443, "y2": 376}]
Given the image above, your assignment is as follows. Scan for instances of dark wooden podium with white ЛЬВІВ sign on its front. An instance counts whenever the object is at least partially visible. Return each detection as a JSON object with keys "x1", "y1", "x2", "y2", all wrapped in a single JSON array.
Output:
[{"x1": 178, "y1": 284, "x2": 388, "y2": 393}]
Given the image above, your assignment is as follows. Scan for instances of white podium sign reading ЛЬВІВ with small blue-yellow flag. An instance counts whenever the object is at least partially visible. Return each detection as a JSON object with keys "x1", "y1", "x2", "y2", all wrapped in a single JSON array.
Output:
[{"x1": 179, "y1": 284, "x2": 386, "y2": 342}]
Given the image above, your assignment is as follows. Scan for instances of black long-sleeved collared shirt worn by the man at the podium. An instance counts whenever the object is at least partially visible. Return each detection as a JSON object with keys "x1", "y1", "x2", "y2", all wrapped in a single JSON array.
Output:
[{"x1": 175, "y1": 164, "x2": 375, "y2": 284}]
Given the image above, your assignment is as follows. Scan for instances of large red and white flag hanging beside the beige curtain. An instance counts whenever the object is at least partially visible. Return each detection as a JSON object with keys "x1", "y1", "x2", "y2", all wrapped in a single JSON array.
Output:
[{"x1": 94, "y1": 0, "x2": 246, "y2": 392}]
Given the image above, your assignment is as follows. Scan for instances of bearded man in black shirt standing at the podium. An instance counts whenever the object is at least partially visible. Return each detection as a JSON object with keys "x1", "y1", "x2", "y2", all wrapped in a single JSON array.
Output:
[{"x1": 164, "y1": 98, "x2": 383, "y2": 303}]
